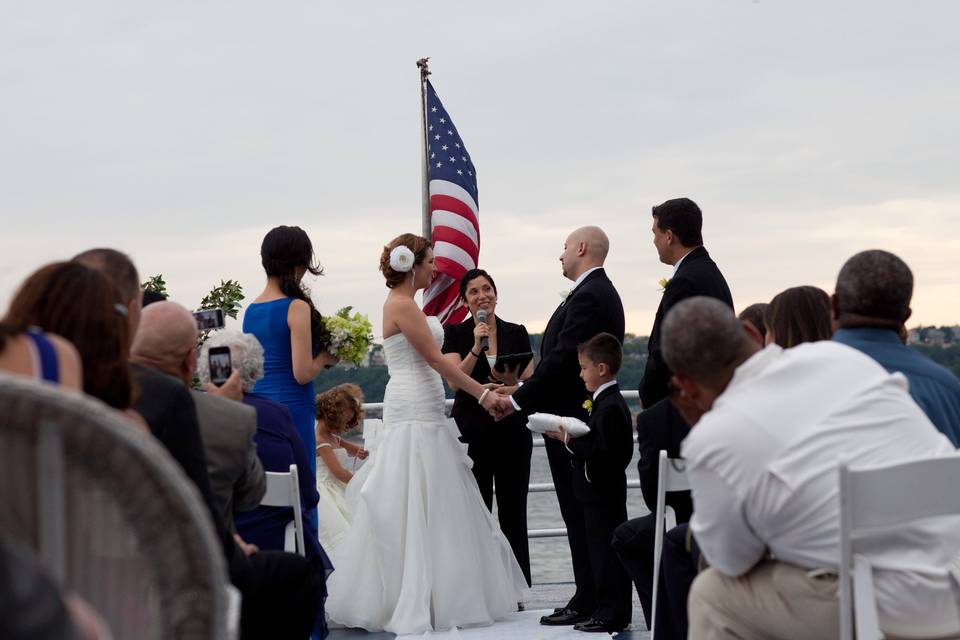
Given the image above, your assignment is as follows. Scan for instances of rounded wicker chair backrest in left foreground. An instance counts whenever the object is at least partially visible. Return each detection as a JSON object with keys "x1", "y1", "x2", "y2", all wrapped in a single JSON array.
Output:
[{"x1": 0, "y1": 375, "x2": 227, "y2": 639}]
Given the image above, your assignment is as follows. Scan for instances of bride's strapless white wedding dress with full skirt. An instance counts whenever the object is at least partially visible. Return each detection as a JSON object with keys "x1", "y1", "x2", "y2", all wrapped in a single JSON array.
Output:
[{"x1": 326, "y1": 316, "x2": 526, "y2": 634}]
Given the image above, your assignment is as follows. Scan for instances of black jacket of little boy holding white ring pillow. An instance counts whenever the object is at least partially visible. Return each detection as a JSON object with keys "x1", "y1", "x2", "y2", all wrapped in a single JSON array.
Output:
[{"x1": 567, "y1": 385, "x2": 633, "y2": 508}]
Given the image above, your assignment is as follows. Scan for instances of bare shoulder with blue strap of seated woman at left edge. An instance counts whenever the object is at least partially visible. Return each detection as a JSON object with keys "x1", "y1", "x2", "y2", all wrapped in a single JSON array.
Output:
[{"x1": 0, "y1": 321, "x2": 83, "y2": 391}]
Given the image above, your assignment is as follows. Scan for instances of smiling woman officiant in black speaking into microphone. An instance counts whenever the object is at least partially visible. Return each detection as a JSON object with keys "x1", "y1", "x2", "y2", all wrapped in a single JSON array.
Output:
[{"x1": 443, "y1": 269, "x2": 533, "y2": 584}]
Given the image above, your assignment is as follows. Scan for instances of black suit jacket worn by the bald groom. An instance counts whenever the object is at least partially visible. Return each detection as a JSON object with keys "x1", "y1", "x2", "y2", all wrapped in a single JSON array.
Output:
[{"x1": 513, "y1": 268, "x2": 623, "y2": 421}]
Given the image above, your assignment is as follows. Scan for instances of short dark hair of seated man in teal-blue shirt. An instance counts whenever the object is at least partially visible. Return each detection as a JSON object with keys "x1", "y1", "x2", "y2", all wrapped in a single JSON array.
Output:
[{"x1": 835, "y1": 249, "x2": 913, "y2": 326}]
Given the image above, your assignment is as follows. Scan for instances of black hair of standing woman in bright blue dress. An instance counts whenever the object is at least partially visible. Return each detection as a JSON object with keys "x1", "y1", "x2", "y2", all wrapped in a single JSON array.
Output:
[{"x1": 260, "y1": 225, "x2": 323, "y2": 325}]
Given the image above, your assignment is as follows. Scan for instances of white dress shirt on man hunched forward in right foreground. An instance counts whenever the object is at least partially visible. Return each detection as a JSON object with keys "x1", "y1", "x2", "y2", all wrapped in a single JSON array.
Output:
[{"x1": 682, "y1": 341, "x2": 960, "y2": 637}]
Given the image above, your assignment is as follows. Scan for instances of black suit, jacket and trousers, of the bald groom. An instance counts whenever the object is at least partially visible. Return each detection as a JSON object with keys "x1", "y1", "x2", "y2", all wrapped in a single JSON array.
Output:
[{"x1": 513, "y1": 268, "x2": 623, "y2": 614}]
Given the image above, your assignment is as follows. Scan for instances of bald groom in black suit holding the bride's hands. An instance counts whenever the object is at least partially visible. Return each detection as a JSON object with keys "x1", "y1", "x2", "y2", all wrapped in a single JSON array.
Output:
[{"x1": 494, "y1": 227, "x2": 623, "y2": 625}]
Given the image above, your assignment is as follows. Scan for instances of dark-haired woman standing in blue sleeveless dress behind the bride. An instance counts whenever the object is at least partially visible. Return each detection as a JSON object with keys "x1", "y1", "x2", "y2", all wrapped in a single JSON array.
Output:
[{"x1": 243, "y1": 226, "x2": 338, "y2": 476}]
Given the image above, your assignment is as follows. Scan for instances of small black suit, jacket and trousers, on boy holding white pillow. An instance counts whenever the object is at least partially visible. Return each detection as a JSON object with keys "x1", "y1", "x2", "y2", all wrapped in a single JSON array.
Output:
[{"x1": 567, "y1": 385, "x2": 633, "y2": 627}]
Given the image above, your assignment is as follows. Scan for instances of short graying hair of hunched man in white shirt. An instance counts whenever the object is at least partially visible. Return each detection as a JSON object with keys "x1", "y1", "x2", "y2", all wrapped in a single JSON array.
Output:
[{"x1": 660, "y1": 296, "x2": 750, "y2": 384}]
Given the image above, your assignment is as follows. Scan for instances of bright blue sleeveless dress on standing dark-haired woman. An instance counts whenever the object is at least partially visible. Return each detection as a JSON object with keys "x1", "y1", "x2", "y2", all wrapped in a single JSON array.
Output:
[{"x1": 243, "y1": 298, "x2": 317, "y2": 477}]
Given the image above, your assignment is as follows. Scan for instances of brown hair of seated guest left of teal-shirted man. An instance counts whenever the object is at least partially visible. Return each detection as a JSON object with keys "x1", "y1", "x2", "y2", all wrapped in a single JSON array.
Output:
[{"x1": 763, "y1": 286, "x2": 833, "y2": 349}]
